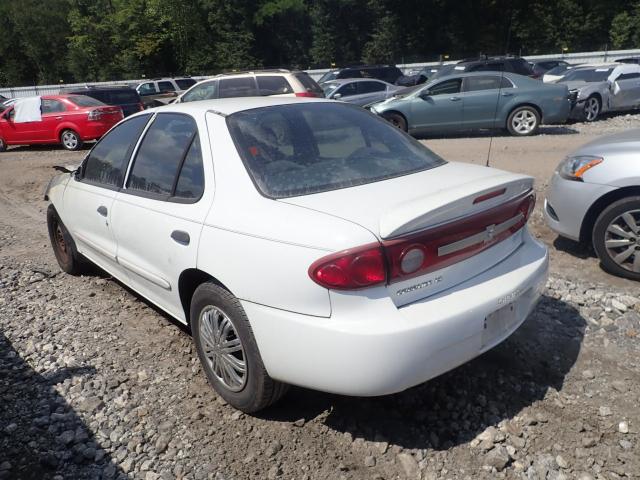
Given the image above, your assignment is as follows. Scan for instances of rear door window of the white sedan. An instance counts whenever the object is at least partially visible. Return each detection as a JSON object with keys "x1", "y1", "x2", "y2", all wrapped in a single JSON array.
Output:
[{"x1": 127, "y1": 113, "x2": 198, "y2": 198}]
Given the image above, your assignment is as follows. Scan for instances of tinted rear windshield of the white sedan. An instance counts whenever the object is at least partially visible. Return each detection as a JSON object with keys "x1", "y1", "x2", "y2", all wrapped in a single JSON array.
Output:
[{"x1": 227, "y1": 103, "x2": 444, "y2": 198}]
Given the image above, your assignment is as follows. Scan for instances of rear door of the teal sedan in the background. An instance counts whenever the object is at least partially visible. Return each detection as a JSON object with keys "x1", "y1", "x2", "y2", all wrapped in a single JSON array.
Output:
[{"x1": 462, "y1": 75, "x2": 513, "y2": 128}]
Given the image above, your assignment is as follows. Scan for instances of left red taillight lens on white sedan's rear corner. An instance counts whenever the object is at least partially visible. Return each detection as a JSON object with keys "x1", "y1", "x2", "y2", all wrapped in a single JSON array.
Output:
[{"x1": 309, "y1": 245, "x2": 387, "y2": 290}]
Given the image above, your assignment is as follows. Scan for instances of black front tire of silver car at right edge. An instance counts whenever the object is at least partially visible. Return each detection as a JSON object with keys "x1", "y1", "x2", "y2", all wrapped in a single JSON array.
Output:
[{"x1": 593, "y1": 196, "x2": 640, "y2": 280}]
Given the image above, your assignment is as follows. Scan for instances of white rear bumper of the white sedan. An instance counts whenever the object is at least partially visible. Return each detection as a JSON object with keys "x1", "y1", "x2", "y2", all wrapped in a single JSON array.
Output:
[{"x1": 242, "y1": 232, "x2": 548, "y2": 396}]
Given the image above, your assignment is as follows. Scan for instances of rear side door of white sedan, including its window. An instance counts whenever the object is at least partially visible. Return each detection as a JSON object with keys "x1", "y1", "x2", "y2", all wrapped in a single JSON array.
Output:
[{"x1": 111, "y1": 112, "x2": 212, "y2": 320}]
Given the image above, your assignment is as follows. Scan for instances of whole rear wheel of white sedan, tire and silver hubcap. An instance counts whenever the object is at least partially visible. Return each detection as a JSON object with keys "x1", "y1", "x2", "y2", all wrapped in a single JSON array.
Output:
[{"x1": 190, "y1": 282, "x2": 287, "y2": 413}]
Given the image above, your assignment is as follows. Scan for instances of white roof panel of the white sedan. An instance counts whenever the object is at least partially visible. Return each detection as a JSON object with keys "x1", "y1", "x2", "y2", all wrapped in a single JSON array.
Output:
[{"x1": 136, "y1": 96, "x2": 332, "y2": 116}]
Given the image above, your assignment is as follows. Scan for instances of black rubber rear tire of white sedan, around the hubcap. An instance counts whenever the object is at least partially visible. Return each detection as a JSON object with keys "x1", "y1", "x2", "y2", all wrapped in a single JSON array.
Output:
[{"x1": 190, "y1": 282, "x2": 288, "y2": 413}]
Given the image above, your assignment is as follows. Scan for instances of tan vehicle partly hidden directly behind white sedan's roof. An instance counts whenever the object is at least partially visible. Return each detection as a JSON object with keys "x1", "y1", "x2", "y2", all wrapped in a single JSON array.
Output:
[{"x1": 177, "y1": 69, "x2": 324, "y2": 103}]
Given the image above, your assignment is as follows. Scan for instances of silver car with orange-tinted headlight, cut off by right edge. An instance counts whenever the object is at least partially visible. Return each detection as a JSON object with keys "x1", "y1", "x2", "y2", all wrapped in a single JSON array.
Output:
[{"x1": 544, "y1": 130, "x2": 640, "y2": 280}]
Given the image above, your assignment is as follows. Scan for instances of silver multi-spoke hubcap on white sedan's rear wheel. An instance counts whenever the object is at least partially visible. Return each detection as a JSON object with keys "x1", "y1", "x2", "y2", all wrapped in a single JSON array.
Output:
[{"x1": 199, "y1": 306, "x2": 247, "y2": 392}]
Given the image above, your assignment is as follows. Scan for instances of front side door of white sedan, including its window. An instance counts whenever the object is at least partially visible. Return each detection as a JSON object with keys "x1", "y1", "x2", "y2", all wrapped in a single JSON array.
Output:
[{"x1": 58, "y1": 115, "x2": 151, "y2": 280}]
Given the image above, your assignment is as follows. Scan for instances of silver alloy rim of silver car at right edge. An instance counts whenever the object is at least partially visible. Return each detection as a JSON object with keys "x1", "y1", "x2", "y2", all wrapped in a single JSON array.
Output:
[{"x1": 604, "y1": 210, "x2": 640, "y2": 273}]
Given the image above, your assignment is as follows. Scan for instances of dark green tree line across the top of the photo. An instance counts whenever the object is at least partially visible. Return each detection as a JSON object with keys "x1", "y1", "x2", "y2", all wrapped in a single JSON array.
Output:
[{"x1": 0, "y1": 0, "x2": 640, "y2": 86}]
